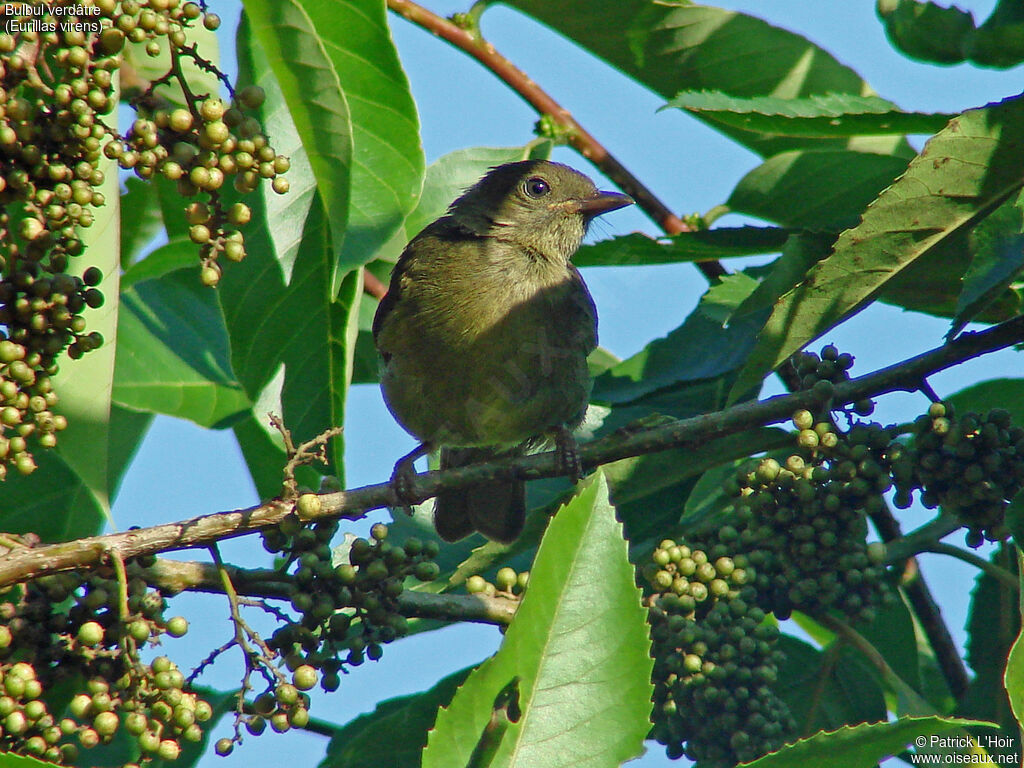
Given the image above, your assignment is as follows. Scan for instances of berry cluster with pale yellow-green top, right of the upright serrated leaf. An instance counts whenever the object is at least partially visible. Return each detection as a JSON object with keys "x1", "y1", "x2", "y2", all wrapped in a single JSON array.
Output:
[{"x1": 643, "y1": 539, "x2": 796, "y2": 768}]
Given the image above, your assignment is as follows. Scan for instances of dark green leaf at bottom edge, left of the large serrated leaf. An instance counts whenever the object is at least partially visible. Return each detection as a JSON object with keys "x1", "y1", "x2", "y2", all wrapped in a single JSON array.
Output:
[{"x1": 319, "y1": 667, "x2": 473, "y2": 768}]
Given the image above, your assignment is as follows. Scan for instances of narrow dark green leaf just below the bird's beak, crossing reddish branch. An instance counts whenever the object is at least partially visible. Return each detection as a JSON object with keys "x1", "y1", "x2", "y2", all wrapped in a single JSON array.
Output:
[{"x1": 572, "y1": 226, "x2": 788, "y2": 266}]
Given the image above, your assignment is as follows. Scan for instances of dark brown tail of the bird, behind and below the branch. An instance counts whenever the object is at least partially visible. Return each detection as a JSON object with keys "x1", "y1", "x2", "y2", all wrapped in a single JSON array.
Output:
[{"x1": 434, "y1": 446, "x2": 526, "y2": 544}]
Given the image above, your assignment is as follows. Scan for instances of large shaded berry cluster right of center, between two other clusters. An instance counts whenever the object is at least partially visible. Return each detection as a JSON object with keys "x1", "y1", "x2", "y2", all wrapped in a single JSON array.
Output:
[{"x1": 718, "y1": 411, "x2": 894, "y2": 622}]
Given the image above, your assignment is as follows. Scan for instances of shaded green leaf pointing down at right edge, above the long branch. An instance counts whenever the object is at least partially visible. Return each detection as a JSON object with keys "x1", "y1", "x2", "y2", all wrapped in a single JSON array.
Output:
[{"x1": 946, "y1": 191, "x2": 1024, "y2": 338}]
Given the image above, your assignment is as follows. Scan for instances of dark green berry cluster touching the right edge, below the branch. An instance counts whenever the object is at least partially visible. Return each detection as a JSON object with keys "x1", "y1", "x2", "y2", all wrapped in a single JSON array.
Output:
[{"x1": 893, "y1": 402, "x2": 1024, "y2": 547}]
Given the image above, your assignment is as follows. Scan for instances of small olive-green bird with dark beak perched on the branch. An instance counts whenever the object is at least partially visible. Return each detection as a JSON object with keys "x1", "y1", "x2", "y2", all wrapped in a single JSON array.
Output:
[{"x1": 374, "y1": 161, "x2": 633, "y2": 543}]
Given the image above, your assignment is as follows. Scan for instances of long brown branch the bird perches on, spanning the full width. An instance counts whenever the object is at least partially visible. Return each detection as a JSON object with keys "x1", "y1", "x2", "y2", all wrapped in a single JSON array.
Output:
[{"x1": 0, "y1": 316, "x2": 1024, "y2": 587}]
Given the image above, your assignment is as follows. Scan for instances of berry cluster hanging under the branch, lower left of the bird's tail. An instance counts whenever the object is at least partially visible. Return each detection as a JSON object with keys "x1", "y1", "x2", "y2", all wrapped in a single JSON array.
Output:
[{"x1": 249, "y1": 520, "x2": 439, "y2": 754}]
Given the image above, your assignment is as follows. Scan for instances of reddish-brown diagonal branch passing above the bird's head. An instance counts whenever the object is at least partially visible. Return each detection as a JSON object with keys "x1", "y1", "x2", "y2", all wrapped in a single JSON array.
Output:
[{"x1": 387, "y1": 0, "x2": 725, "y2": 280}]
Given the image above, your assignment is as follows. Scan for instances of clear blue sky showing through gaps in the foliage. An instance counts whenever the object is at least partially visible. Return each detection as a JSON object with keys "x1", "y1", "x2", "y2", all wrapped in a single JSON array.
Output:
[{"x1": 105, "y1": 0, "x2": 1020, "y2": 768}]
